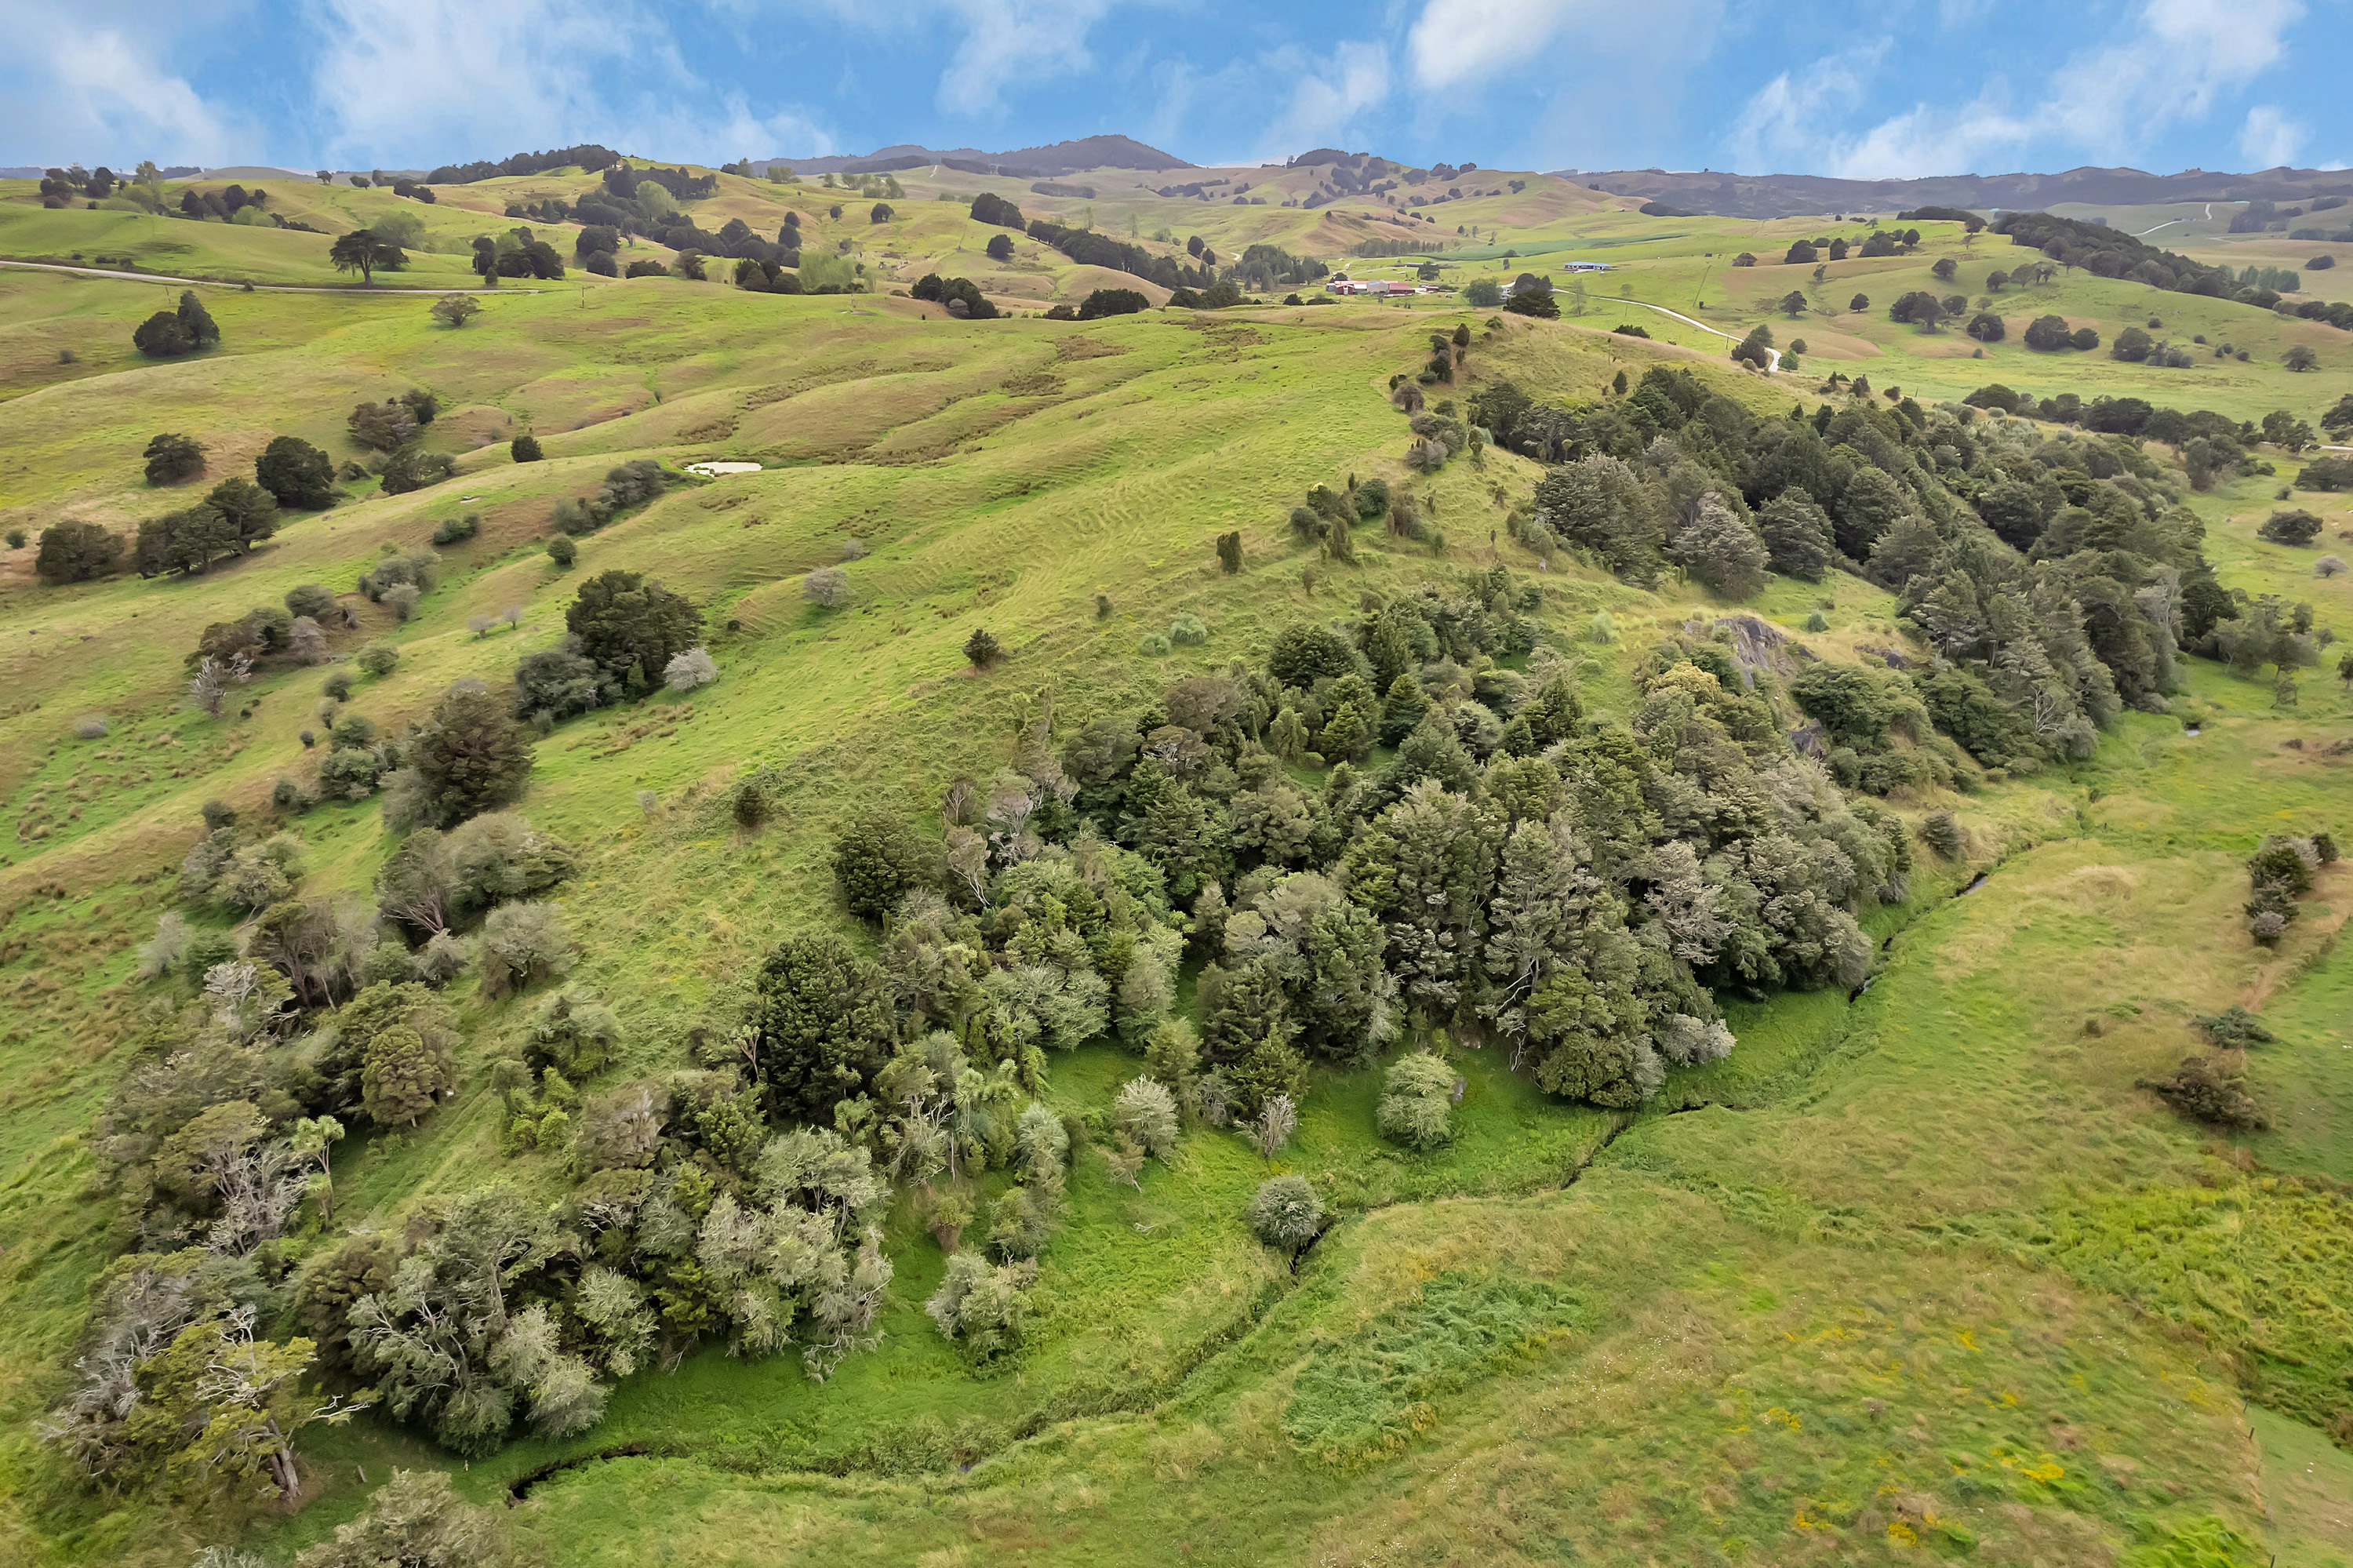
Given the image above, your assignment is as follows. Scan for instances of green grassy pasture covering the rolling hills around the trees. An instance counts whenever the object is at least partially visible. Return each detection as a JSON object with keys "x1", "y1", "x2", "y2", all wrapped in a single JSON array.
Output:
[{"x1": 0, "y1": 169, "x2": 2353, "y2": 1563}]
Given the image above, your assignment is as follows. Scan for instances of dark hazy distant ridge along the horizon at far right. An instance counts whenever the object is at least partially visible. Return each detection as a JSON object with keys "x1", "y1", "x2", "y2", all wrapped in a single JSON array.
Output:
[{"x1": 1551, "y1": 167, "x2": 2353, "y2": 219}]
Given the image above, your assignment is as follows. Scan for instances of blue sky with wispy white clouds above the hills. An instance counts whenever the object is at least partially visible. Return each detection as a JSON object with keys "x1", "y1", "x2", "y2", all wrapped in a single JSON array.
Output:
[{"x1": 0, "y1": 0, "x2": 2353, "y2": 176}]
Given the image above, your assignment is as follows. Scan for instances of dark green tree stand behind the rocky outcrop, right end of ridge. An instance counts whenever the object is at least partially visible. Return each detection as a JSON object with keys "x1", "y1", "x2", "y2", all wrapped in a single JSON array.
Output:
[{"x1": 1473, "y1": 355, "x2": 2231, "y2": 767}]
